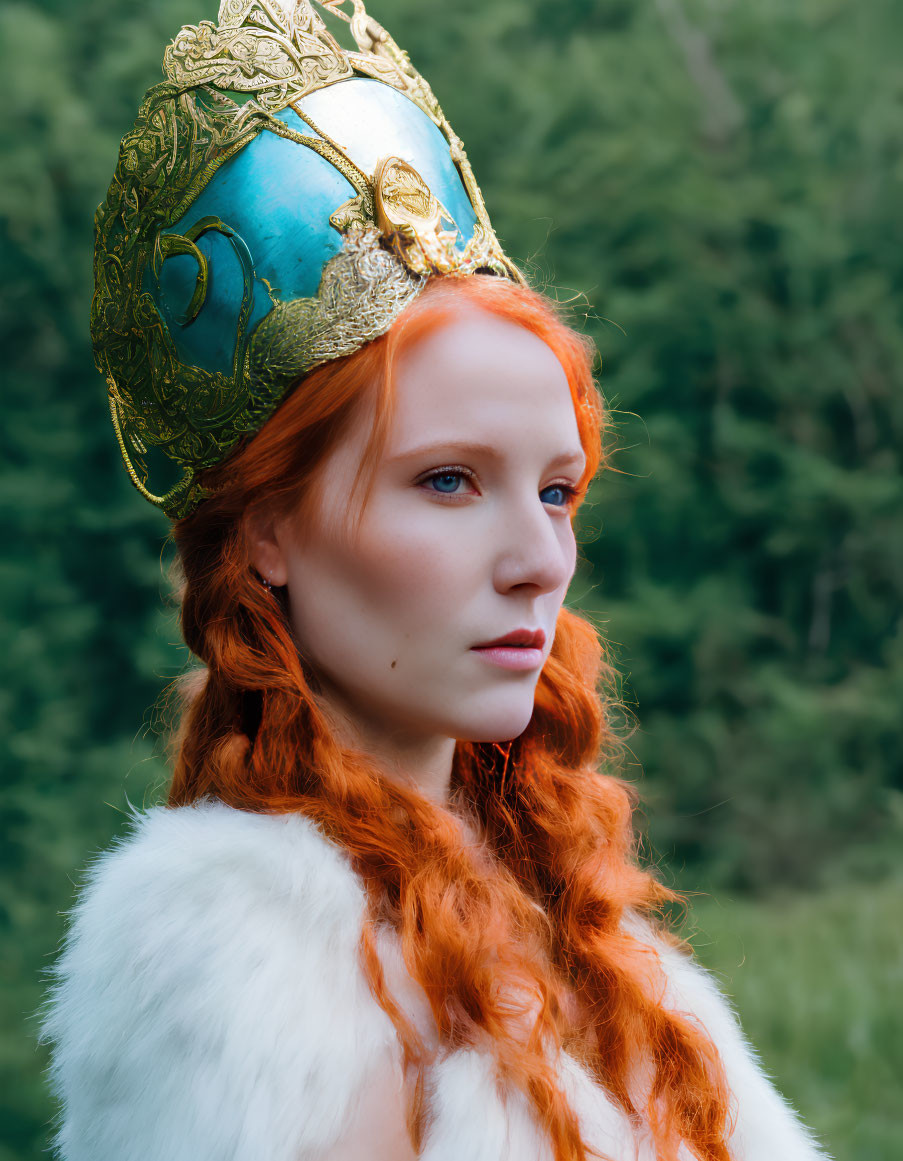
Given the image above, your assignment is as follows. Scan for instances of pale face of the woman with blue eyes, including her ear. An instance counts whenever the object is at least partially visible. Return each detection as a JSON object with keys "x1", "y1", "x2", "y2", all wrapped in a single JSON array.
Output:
[{"x1": 246, "y1": 307, "x2": 585, "y2": 742}]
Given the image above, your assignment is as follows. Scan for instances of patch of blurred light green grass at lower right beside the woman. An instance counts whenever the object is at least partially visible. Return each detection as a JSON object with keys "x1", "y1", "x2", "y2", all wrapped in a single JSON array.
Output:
[{"x1": 692, "y1": 878, "x2": 903, "y2": 1161}]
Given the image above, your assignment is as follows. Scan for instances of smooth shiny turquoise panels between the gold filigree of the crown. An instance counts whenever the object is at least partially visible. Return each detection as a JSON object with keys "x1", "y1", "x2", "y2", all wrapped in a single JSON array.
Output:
[{"x1": 144, "y1": 78, "x2": 477, "y2": 373}]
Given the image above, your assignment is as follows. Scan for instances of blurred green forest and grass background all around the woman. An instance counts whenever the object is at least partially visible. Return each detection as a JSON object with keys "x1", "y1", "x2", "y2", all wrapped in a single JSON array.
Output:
[{"x1": 0, "y1": 0, "x2": 903, "y2": 1161}]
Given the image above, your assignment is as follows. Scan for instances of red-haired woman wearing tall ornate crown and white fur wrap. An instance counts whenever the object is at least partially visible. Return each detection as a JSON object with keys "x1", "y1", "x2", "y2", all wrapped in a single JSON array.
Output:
[{"x1": 44, "y1": 0, "x2": 823, "y2": 1161}]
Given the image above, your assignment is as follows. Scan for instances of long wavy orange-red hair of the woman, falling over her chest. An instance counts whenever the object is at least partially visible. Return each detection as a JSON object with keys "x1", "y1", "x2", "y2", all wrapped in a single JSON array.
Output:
[{"x1": 169, "y1": 275, "x2": 730, "y2": 1161}]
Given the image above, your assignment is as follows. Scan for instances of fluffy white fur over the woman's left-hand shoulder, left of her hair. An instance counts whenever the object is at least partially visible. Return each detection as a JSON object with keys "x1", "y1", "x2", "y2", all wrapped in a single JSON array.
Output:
[{"x1": 42, "y1": 802, "x2": 391, "y2": 1161}]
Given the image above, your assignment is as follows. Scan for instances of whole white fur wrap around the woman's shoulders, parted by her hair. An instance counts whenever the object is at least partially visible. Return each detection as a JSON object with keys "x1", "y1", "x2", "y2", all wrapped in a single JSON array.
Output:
[{"x1": 42, "y1": 801, "x2": 825, "y2": 1161}]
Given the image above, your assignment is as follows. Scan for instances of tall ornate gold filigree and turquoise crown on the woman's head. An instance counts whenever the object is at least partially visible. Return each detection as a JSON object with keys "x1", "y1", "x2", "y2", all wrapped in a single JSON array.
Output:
[{"x1": 92, "y1": 0, "x2": 522, "y2": 518}]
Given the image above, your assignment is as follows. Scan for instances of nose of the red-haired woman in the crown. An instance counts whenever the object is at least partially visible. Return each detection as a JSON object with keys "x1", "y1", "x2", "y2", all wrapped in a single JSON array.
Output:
[{"x1": 494, "y1": 496, "x2": 576, "y2": 592}]
